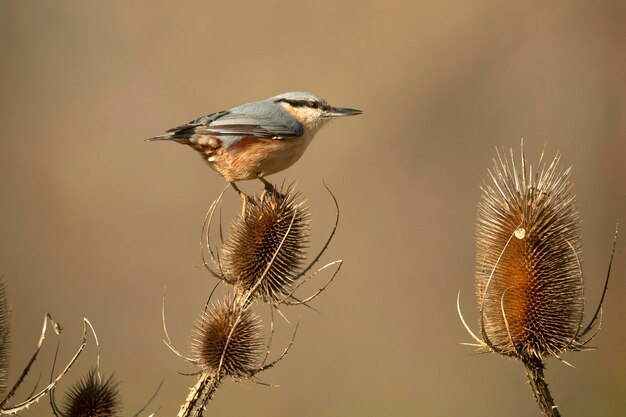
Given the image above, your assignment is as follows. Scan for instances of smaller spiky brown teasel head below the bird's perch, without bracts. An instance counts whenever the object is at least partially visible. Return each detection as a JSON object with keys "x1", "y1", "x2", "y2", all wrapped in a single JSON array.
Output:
[{"x1": 191, "y1": 297, "x2": 264, "y2": 378}]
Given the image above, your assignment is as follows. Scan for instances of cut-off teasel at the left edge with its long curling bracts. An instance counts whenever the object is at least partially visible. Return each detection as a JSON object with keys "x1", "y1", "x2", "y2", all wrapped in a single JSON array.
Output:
[{"x1": 0, "y1": 280, "x2": 93, "y2": 415}]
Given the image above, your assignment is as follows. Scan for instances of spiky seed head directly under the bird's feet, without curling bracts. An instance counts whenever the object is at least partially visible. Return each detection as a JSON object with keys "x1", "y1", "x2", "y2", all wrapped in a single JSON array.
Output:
[{"x1": 221, "y1": 187, "x2": 310, "y2": 302}]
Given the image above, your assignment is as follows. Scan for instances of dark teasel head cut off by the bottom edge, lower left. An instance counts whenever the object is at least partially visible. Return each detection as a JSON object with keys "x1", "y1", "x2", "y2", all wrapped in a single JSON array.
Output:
[{"x1": 63, "y1": 368, "x2": 122, "y2": 417}]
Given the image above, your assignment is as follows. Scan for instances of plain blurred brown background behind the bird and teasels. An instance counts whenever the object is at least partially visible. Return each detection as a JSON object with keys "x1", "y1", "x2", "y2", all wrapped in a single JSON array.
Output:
[{"x1": 0, "y1": 0, "x2": 626, "y2": 417}]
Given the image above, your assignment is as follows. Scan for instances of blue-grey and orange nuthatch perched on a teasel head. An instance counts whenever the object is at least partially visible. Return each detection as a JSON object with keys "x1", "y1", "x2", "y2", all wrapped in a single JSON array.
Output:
[{"x1": 147, "y1": 91, "x2": 362, "y2": 215}]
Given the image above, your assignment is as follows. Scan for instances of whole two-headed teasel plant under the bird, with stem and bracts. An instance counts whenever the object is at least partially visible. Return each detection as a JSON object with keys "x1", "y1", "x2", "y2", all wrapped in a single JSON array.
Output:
[{"x1": 163, "y1": 182, "x2": 342, "y2": 417}]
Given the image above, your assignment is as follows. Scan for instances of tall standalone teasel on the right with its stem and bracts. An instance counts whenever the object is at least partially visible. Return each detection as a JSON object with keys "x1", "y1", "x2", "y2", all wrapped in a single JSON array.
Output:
[{"x1": 457, "y1": 143, "x2": 617, "y2": 417}]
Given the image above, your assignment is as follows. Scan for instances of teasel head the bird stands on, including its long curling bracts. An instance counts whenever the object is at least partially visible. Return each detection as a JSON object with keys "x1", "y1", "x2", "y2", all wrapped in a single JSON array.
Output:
[{"x1": 200, "y1": 185, "x2": 342, "y2": 307}]
